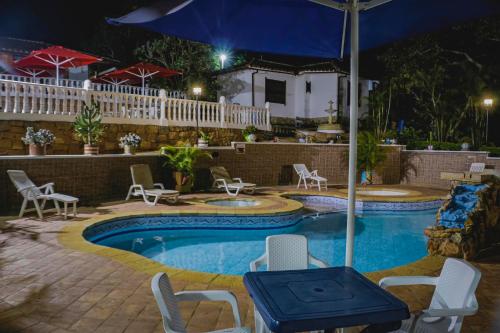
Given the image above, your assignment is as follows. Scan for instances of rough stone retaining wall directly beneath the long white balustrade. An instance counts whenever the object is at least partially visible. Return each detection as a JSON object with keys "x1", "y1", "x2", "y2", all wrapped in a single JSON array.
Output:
[{"x1": 0, "y1": 120, "x2": 243, "y2": 155}]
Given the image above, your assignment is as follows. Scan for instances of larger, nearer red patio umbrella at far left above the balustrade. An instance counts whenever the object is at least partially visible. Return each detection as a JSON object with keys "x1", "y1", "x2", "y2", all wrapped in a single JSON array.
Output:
[{"x1": 14, "y1": 46, "x2": 102, "y2": 84}]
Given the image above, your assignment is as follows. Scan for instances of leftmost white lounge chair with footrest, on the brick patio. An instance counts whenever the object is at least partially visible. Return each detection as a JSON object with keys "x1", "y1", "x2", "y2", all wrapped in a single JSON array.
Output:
[{"x1": 7, "y1": 170, "x2": 78, "y2": 219}]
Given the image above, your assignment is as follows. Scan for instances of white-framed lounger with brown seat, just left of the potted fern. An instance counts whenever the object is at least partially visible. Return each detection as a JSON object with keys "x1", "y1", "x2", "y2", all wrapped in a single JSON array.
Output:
[{"x1": 125, "y1": 164, "x2": 179, "y2": 206}]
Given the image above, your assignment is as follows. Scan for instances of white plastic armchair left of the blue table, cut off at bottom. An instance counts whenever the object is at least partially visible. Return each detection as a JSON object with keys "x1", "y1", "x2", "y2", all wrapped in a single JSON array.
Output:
[{"x1": 151, "y1": 273, "x2": 250, "y2": 333}]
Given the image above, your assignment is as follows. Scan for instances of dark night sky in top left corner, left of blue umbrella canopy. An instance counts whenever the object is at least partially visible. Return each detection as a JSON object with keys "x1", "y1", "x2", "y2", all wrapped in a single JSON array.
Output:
[{"x1": 0, "y1": 0, "x2": 152, "y2": 48}]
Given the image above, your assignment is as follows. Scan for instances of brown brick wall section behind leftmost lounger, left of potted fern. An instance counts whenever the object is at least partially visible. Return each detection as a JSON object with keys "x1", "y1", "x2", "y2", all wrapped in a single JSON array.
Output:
[{"x1": 0, "y1": 155, "x2": 161, "y2": 213}]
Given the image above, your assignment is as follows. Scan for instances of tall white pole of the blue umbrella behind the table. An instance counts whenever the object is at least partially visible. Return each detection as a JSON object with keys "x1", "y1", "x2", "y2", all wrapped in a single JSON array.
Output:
[{"x1": 345, "y1": 0, "x2": 359, "y2": 266}]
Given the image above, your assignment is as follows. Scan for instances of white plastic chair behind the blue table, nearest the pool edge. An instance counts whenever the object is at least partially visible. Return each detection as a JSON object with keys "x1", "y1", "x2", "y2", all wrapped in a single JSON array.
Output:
[{"x1": 250, "y1": 235, "x2": 328, "y2": 333}]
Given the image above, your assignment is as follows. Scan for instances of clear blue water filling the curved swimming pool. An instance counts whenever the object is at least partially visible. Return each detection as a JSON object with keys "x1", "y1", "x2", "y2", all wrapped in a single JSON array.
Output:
[{"x1": 97, "y1": 210, "x2": 436, "y2": 275}]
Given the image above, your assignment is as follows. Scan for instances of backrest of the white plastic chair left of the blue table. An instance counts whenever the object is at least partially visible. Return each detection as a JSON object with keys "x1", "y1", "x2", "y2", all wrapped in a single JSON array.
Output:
[{"x1": 151, "y1": 273, "x2": 186, "y2": 332}]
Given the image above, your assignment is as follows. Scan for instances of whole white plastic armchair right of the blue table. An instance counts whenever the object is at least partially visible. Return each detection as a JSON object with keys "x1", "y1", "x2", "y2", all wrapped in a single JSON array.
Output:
[{"x1": 379, "y1": 258, "x2": 481, "y2": 333}]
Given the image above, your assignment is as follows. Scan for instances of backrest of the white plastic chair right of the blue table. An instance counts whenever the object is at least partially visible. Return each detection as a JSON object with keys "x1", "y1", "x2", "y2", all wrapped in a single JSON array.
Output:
[{"x1": 430, "y1": 258, "x2": 481, "y2": 328}]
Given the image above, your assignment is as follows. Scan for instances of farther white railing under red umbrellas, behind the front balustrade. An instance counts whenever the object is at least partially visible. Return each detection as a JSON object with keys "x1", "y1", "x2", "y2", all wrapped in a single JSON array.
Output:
[{"x1": 0, "y1": 74, "x2": 186, "y2": 98}]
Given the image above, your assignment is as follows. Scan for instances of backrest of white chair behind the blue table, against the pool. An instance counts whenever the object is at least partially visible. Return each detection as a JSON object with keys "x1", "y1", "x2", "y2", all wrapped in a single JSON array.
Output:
[{"x1": 266, "y1": 235, "x2": 309, "y2": 271}]
